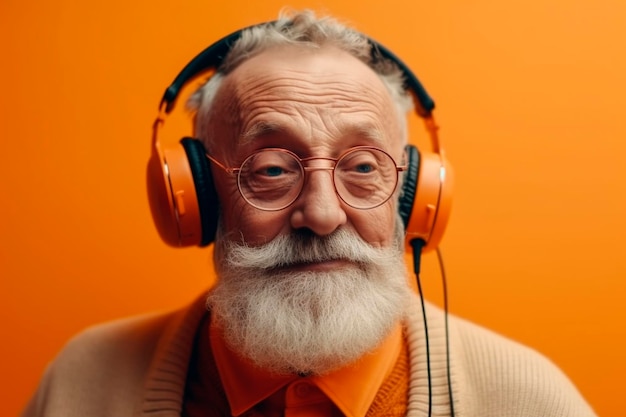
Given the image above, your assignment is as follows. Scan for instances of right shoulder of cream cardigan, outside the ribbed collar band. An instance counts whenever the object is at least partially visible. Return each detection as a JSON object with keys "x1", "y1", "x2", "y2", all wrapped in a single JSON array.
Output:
[{"x1": 451, "y1": 318, "x2": 596, "y2": 417}]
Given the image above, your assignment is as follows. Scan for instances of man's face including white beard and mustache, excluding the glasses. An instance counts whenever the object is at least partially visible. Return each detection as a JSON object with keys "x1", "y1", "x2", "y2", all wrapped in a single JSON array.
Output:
[{"x1": 202, "y1": 47, "x2": 410, "y2": 374}]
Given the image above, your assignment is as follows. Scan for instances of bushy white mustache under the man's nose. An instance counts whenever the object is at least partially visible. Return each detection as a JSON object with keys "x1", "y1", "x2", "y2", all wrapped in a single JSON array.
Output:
[{"x1": 226, "y1": 229, "x2": 397, "y2": 269}]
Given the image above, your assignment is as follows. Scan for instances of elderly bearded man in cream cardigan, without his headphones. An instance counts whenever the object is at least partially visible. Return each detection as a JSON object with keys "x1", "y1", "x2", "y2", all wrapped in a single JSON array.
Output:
[{"x1": 24, "y1": 12, "x2": 594, "y2": 417}]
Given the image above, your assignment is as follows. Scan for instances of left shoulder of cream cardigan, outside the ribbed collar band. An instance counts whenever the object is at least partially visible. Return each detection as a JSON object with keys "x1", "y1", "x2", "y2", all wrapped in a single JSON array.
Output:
[{"x1": 22, "y1": 316, "x2": 171, "y2": 417}]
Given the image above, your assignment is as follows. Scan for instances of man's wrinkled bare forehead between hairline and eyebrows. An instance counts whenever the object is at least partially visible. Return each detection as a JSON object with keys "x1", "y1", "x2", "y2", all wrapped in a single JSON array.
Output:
[{"x1": 214, "y1": 46, "x2": 400, "y2": 156}]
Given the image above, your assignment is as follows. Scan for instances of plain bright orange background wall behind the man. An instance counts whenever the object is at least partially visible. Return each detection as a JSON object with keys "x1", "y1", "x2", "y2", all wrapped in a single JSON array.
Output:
[{"x1": 0, "y1": 0, "x2": 626, "y2": 416}]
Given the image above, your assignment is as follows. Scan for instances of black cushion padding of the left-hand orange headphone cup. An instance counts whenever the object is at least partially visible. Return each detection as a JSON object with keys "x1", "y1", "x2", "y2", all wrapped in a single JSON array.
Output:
[{"x1": 180, "y1": 137, "x2": 219, "y2": 246}]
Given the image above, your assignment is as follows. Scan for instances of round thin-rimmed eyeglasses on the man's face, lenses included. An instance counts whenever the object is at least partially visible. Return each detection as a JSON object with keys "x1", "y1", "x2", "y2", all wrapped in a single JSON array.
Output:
[{"x1": 206, "y1": 146, "x2": 407, "y2": 211}]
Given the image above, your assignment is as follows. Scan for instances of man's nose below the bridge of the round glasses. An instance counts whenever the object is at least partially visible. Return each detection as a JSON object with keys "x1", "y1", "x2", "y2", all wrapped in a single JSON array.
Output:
[{"x1": 291, "y1": 169, "x2": 347, "y2": 236}]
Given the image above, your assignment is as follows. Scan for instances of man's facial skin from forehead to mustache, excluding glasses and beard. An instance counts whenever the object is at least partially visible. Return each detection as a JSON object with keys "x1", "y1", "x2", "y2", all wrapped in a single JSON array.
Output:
[{"x1": 209, "y1": 46, "x2": 403, "y2": 254}]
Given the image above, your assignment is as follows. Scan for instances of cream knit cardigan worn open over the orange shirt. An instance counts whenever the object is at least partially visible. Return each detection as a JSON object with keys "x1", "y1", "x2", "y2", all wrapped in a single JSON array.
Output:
[{"x1": 22, "y1": 296, "x2": 595, "y2": 417}]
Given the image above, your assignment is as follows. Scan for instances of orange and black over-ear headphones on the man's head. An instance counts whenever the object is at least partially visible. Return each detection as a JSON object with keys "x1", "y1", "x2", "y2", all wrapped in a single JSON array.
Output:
[{"x1": 147, "y1": 22, "x2": 453, "y2": 251}]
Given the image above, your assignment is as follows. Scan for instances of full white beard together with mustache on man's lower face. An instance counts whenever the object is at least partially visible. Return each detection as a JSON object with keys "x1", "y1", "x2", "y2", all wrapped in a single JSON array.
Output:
[{"x1": 207, "y1": 223, "x2": 411, "y2": 374}]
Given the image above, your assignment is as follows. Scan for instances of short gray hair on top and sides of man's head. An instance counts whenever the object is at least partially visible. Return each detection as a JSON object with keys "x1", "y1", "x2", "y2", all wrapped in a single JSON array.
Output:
[{"x1": 187, "y1": 10, "x2": 413, "y2": 148}]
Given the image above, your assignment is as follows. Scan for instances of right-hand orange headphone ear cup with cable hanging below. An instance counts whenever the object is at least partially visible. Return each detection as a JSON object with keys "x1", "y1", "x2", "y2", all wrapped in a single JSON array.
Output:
[{"x1": 398, "y1": 145, "x2": 453, "y2": 252}]
